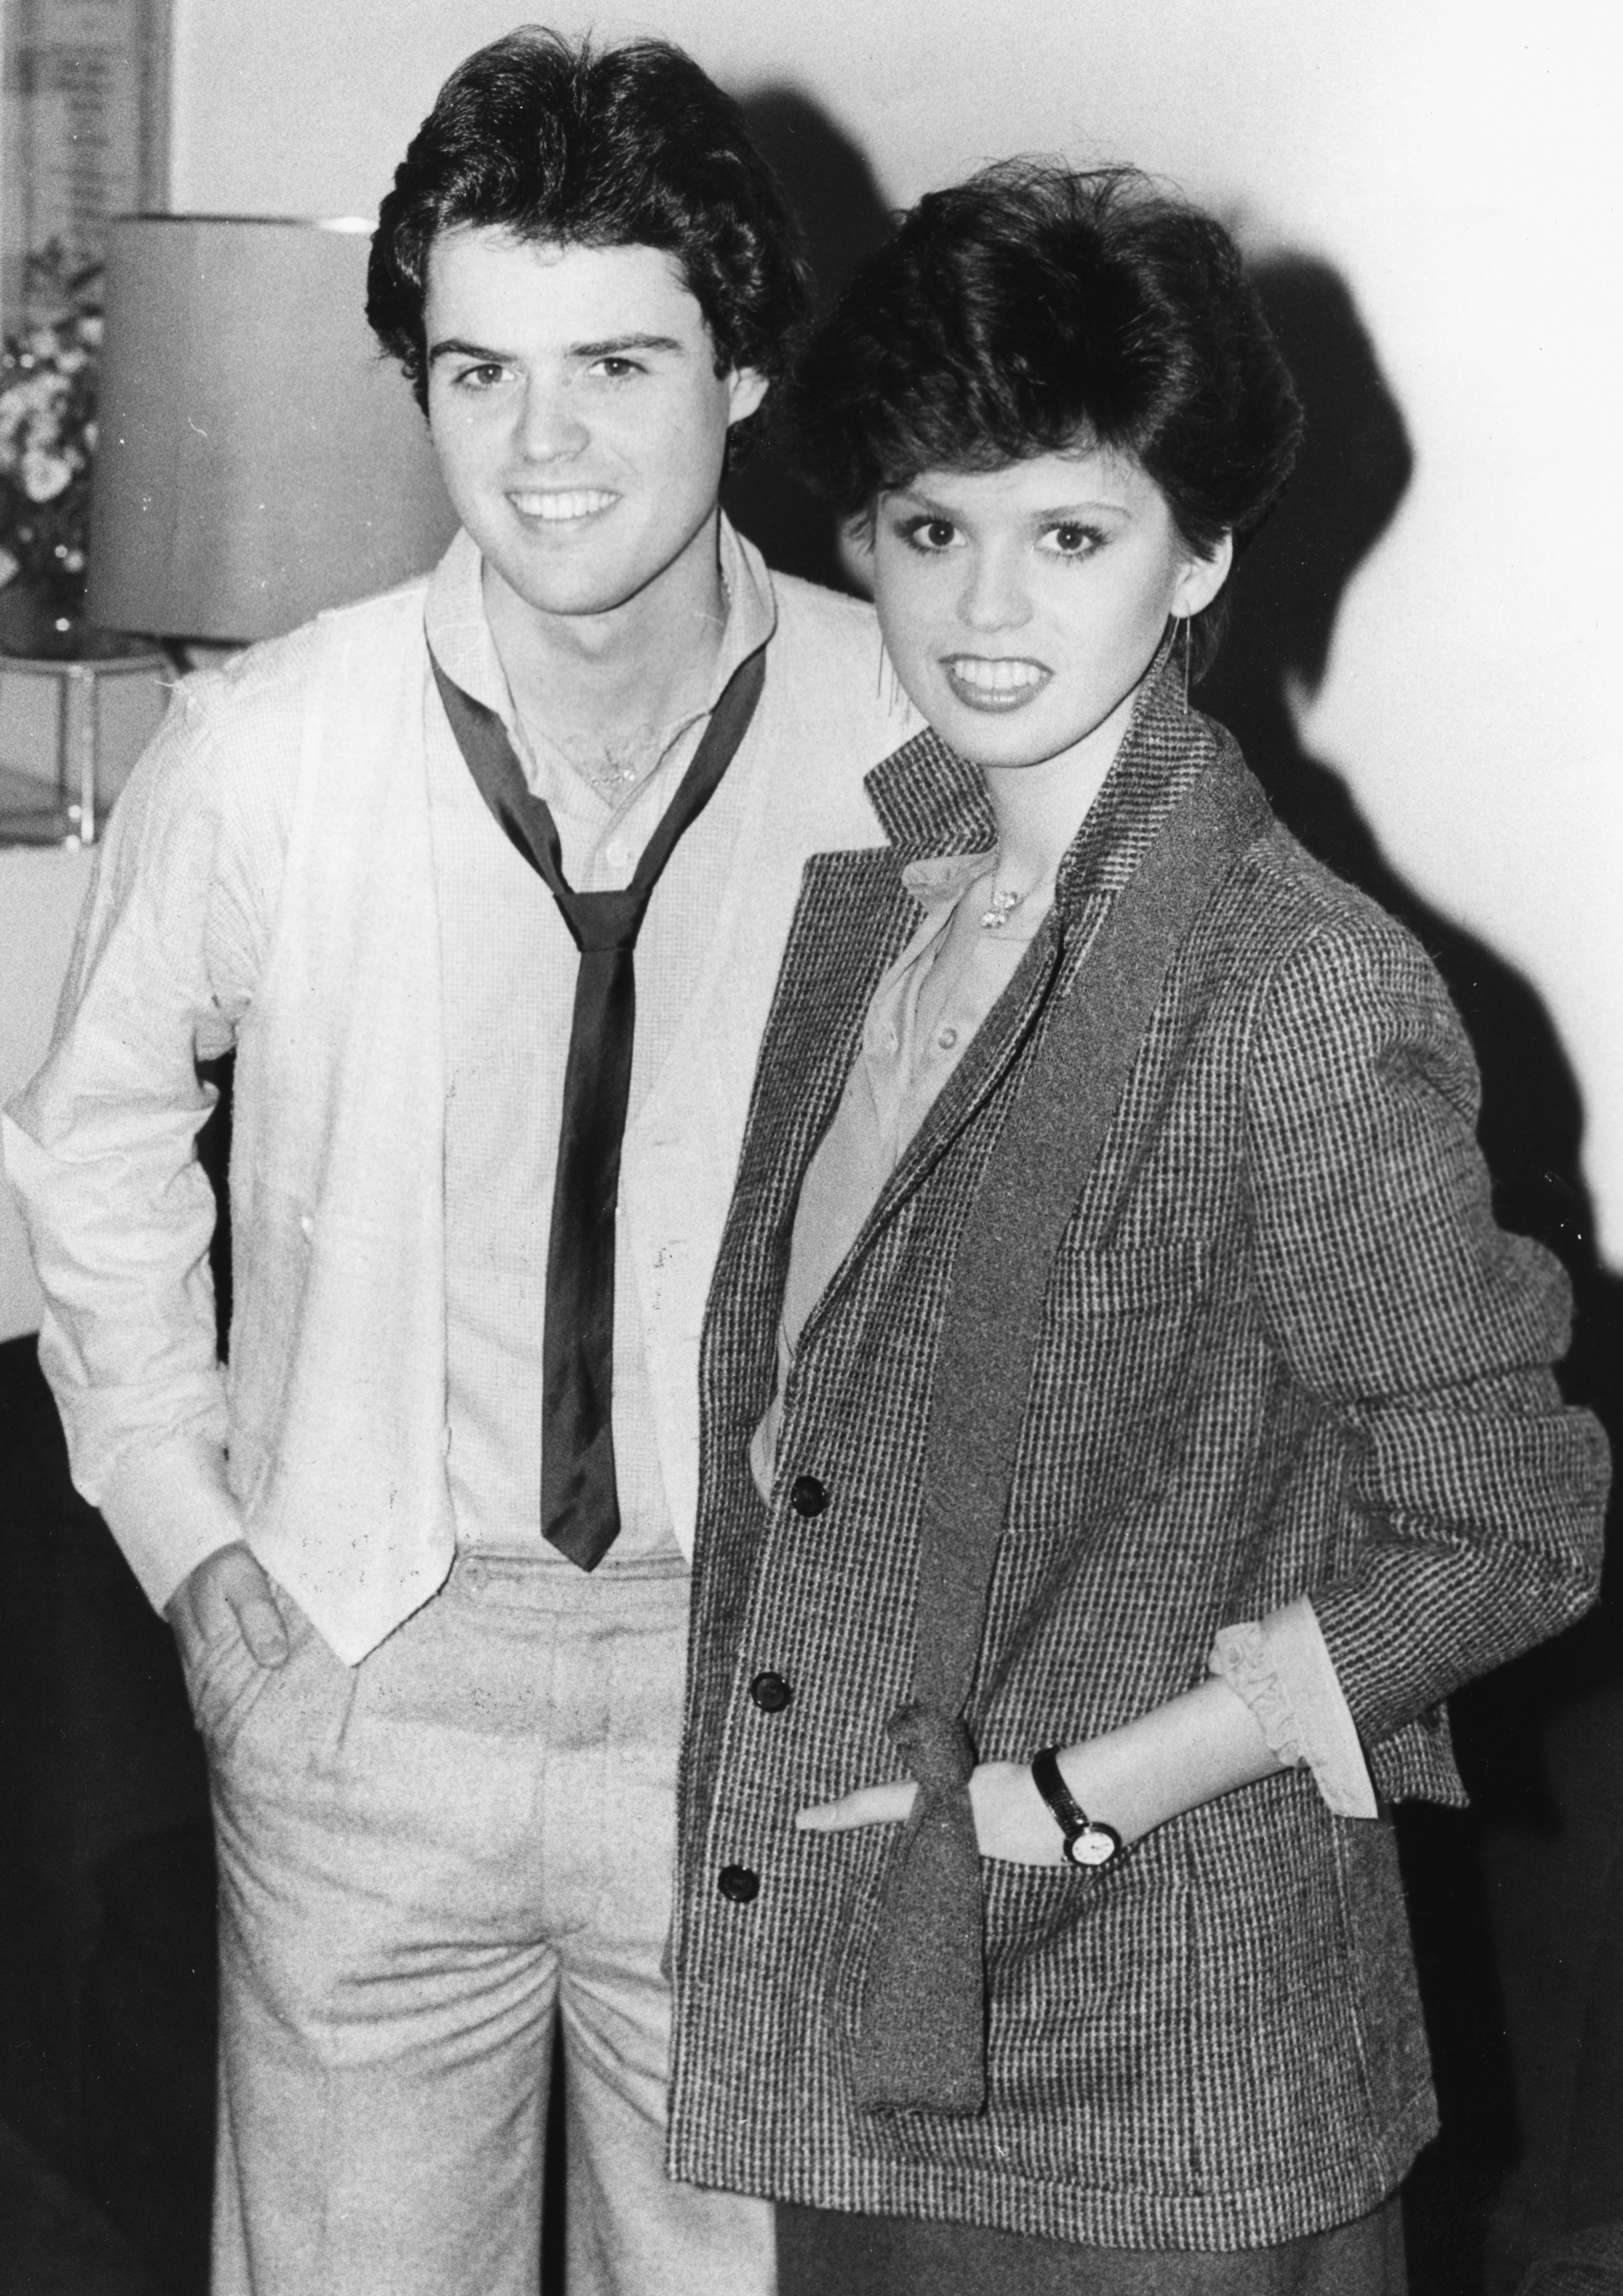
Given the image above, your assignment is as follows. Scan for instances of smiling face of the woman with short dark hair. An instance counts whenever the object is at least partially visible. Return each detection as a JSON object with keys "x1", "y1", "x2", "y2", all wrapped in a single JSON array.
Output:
[{"x1": 872, "y1": 448, "x2": 1233, "y2": 767}]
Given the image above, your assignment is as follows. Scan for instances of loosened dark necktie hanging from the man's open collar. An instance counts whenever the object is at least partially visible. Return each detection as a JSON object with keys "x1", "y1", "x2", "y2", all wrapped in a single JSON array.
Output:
[{"x1": 429, "y1": 652, "x2": 767, "y2": 1571}]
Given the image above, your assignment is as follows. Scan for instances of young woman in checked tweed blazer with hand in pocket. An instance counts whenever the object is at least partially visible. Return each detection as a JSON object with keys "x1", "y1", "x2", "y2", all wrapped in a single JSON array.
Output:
[{"x1": 673, "y1": 165, "x2": 1604, "y2": 2296}]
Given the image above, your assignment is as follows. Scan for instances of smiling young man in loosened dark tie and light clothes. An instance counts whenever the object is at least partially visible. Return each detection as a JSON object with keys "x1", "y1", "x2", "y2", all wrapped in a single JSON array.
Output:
[{"x1": 7, "y1": 30, "x2": 909, "y2": 2296}]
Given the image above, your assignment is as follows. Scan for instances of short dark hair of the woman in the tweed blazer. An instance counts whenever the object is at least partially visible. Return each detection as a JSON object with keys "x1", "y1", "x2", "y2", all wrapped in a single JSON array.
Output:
[{"x1": 790, "y1": 161, "x2": 1301, "y2": 664}]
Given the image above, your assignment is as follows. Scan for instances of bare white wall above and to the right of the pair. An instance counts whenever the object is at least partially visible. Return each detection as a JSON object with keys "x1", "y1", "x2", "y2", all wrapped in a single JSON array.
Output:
[{"x1": 156, "y1": 0, "x2": 1623, "y2": 1263}]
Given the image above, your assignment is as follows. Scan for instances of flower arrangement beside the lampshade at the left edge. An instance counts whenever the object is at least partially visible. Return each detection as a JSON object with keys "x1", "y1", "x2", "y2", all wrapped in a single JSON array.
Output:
[{"x1": 0, "y1": 246, "x2": 101, "y2": 638}]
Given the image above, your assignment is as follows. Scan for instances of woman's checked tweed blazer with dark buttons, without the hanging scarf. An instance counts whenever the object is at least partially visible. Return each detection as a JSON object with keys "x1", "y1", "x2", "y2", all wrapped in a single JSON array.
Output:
[{"x1": 670, "y1": 677, "x2": 1607, "y2": 2250}]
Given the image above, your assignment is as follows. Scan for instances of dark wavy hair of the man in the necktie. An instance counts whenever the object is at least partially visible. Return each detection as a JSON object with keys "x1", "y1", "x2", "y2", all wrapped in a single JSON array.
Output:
[{"x1": 367, "y1": 25, "x2": 811, "y2": 441}]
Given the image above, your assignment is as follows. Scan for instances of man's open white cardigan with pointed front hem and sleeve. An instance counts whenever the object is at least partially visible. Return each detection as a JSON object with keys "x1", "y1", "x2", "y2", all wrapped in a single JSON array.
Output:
[{"x1": 5, "y1": 530, "x2": 914, "y2": 1662}]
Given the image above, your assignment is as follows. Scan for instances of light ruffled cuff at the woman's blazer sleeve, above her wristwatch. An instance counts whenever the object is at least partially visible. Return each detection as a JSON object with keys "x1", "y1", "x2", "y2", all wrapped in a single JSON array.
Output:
[{"x1": 1207, "y1": 1596, "x2": 1378, "y2": 1818}]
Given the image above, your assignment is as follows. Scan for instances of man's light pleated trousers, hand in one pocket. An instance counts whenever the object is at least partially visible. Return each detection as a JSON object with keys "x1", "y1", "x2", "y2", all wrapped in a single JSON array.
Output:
[{"x1": 181, "y1": 1554, "x2": 773, "y2": 2296}]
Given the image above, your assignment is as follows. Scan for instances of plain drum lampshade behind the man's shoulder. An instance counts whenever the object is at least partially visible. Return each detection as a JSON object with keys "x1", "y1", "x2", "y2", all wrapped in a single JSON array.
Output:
[{"x1": 87, "y1": 216, "x2": 457, "y2": 643}]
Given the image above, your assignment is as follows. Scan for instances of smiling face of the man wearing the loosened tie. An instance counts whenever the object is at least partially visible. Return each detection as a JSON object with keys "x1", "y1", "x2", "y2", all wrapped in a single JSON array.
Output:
[{"x1": 425, "y1": 227, "x2": 767, "y2": 616}]
